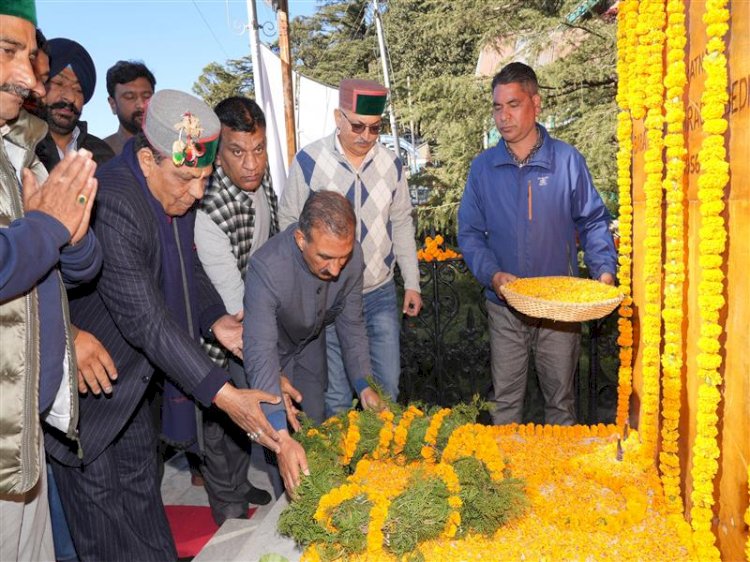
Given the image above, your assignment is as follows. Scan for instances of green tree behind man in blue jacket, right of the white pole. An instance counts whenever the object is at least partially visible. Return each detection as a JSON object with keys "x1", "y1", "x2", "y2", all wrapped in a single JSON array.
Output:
[{"x1": 384, "y1": 0, "x2": 616, "y2": 235}]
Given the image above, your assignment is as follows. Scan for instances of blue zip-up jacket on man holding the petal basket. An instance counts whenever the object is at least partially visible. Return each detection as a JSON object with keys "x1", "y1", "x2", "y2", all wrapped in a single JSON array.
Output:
[{"x1": 458, "y1": 125, "x2": 617, "y2": 304}]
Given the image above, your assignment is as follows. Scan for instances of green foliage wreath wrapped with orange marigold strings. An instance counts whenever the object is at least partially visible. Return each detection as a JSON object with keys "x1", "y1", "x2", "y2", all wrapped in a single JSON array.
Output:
[{"x1": 280, "y1": 403, "x2": 525, "y2": 561}]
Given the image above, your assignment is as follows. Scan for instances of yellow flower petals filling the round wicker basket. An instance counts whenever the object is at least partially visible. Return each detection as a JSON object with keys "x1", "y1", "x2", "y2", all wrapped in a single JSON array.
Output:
[{"x1": 506, "y1": 277, "x2": 620, "y2": 304}]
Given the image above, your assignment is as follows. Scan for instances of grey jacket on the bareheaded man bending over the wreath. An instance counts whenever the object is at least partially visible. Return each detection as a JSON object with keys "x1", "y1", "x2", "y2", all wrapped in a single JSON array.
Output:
[{"x1": 243, "y1": 223, "x2": 372, "y2": 429}]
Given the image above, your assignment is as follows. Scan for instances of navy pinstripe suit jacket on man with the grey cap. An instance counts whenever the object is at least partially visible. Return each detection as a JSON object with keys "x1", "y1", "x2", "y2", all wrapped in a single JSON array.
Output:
[{"x1": 45, "y1": 149, "x2": 229, "y2": 466}]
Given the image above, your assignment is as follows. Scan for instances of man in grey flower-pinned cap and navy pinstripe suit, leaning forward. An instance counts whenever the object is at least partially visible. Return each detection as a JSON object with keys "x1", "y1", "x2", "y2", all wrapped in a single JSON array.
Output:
[{"x1": 46, "y1": 90, "x2": 280, "y2": 561}]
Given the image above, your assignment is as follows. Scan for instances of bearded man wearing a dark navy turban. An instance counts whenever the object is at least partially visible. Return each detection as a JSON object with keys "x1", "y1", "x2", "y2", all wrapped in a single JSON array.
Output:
[{"x1": 36, "y1": 37, "x2": 114, "y2": 171}]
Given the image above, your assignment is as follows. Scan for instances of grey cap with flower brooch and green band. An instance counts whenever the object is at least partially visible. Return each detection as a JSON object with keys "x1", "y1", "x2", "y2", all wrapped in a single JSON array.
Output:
[{"x1": 143, "y1": 90, "x2": 221, "y2": 168}]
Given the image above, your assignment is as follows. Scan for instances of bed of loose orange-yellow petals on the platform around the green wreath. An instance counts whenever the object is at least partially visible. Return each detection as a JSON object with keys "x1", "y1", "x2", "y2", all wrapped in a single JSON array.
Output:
[{"x1": 302, "y1": 424, "x2": 700, "y2": 562}]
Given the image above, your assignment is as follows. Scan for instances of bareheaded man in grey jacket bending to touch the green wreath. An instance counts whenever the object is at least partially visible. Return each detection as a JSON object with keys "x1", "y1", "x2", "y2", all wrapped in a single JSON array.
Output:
[{"x1": 243, "y1": 191, "x2": 381, "y2": 493}]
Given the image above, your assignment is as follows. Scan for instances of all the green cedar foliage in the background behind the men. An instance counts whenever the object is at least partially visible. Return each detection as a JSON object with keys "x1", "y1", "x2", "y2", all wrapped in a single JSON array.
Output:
[{"x1": 194, "y1": 0, "x2": 617, "y2": 233}]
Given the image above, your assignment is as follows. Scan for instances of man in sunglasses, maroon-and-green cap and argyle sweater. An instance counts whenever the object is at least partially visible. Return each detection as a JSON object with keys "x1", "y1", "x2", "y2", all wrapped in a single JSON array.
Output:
[{"x1": 279, "y1": 79, "x2": 422, "y2": 416}]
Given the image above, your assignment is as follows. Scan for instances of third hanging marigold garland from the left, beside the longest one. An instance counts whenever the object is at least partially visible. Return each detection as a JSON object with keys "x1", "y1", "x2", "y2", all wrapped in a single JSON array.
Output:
[{"x1": 659, "y1": 0, "x2": 687, "y2": 515}]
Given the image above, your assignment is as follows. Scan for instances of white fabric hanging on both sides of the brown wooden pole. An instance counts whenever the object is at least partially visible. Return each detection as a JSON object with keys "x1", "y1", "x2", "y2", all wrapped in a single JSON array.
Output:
[{"x1": 255, "y1": 44, "x2": 339, "y2": 194}]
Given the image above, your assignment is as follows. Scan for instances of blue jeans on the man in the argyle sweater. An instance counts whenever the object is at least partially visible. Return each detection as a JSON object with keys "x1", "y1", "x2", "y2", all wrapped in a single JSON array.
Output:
[{"x1": 326, "y1": 281, "x2": 401, "y2": 417}]
